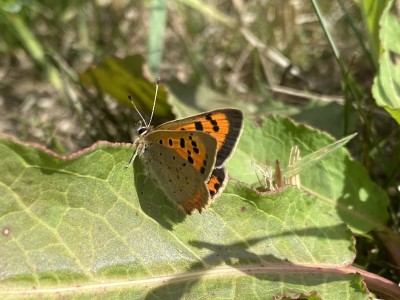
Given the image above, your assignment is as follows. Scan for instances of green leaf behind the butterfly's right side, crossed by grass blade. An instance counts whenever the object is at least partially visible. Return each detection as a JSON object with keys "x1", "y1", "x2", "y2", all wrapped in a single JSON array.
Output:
[{"x1": 228, "y1": 117, "x2": 389, "y2": 233}]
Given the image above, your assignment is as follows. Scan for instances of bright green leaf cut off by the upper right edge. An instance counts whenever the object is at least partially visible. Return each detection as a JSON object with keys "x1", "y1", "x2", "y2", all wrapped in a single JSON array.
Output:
[{"x1": 372, "y1": 1, "x2": 400, "y2": 124}]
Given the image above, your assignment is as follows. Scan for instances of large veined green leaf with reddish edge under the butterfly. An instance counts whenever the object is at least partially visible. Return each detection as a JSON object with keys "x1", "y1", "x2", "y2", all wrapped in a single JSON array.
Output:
[{"x1": 0, "y1": 131, "x2": 368, "y2": 299}]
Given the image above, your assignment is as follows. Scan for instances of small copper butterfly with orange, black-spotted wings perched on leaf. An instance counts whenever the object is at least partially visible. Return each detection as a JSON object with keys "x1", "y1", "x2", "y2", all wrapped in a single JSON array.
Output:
[{"x1": 127, "y1": 78, "x2": 243, "y2": 214}]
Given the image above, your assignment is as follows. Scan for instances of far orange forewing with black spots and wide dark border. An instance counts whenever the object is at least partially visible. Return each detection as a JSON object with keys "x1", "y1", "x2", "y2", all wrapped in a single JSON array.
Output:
[{"x1": 155, "y1": 109, "x2": 243, "y2": 167}]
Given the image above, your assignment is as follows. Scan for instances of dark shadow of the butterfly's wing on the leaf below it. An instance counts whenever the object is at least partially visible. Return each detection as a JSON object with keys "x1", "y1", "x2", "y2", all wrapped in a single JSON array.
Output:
[{"x1": 134, "y1": 159, "x2": 187, "y2": 230}]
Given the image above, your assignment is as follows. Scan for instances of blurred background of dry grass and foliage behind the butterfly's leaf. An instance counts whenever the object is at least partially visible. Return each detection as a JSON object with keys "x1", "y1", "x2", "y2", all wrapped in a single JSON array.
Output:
[{"x1": 0, "y1": 0, "x2": 400, "y2": 281}]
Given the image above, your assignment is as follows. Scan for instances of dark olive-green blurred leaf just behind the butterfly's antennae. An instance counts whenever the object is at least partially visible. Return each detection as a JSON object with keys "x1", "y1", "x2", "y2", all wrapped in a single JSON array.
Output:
[{"x1": 79, "y1": 55, "x2": 173, "y2": 119}]
